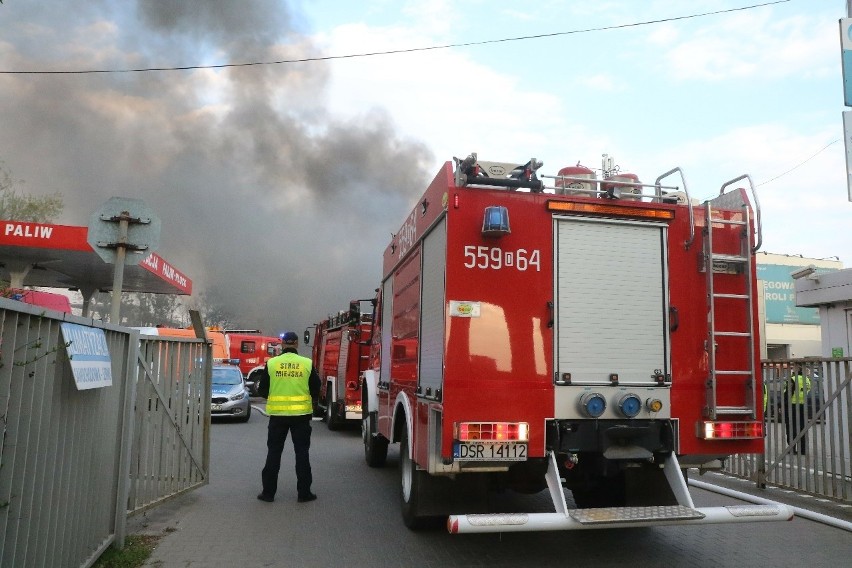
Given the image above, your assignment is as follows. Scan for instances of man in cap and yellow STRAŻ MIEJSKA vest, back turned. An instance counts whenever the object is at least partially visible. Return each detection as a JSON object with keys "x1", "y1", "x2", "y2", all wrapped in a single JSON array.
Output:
[{"x1": 257, "y1": 331, "x2": 320, "y2": 503}]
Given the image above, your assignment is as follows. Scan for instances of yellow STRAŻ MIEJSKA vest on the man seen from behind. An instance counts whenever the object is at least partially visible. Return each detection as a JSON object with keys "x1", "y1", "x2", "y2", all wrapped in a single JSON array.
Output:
[{"x1": 266, "y1": 353, "x2": 314, "y2": 416}]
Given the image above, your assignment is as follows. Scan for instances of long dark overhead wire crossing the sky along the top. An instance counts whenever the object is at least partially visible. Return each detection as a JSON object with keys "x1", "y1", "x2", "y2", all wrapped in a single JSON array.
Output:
[{"x1": 0, "y1": 0, "x2": 790, "y2": 75}]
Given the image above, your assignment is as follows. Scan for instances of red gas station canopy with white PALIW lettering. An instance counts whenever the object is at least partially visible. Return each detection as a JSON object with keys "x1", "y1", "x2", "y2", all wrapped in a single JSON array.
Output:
[{"x1": 0, "y1": 221, "x2": 192, "y2": 295}]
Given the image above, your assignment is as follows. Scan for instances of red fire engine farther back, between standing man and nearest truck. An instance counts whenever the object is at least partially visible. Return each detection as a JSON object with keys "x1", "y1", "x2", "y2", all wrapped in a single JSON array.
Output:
[{"x1": 305, "y1": 300, "x2": 373, "y2": 430}]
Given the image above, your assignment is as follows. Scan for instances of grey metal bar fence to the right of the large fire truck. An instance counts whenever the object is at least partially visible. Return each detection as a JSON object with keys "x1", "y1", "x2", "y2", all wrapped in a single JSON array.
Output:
[{"x1": 725, "y1": 357, "x2": 852, "y2": 502}]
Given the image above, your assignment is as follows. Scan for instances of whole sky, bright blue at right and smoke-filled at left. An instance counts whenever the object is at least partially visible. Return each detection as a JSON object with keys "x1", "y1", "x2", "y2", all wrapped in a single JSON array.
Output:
[{"x1": 0, "y1": 0, "x2": 852, "y2": 333}]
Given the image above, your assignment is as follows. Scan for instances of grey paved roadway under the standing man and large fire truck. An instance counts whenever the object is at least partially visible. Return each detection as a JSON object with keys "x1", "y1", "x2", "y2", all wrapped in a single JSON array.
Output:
[{"x1": 128, "y1": 402, "x2": 852, "y2": 568}]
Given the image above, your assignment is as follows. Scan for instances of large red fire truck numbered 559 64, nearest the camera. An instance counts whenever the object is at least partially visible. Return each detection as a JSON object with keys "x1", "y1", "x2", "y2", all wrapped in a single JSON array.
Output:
[{"x1": 362, "y1": 154, "x2": 792, "y2": 533}]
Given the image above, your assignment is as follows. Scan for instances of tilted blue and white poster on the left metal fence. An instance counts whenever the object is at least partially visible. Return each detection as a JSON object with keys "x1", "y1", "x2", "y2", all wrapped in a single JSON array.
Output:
[{"x1": 60, "y1": 322, "x2": 112, "y2": 390}]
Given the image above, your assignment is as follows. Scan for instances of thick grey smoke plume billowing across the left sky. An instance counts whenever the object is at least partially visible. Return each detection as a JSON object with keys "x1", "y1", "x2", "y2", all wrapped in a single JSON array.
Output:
[{"x1": 0, "y1": 0, "x2": 434, "y2": 333}]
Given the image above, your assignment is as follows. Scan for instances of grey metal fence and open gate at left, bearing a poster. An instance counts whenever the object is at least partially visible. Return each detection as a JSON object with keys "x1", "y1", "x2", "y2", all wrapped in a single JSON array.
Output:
[{"x1": 0, "y1": 298, "x2": 212, "y2": 567}]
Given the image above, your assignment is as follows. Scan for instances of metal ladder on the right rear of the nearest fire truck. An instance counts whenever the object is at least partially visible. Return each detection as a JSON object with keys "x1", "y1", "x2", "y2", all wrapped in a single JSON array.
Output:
[{"x1": 703, "y1": 174, "x2": 763, "y2": 420}]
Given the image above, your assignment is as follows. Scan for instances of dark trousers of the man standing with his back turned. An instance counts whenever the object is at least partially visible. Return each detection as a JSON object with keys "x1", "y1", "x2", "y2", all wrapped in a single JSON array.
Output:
[{"x1": 260, "y1": 414, "x2": 313, "y2": 497}]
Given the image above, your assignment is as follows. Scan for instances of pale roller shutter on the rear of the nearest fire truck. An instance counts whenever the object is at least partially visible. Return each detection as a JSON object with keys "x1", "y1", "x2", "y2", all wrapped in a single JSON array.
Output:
[{"x1": 554, "y1": 218, "x2": 670, "y2": 419}]
